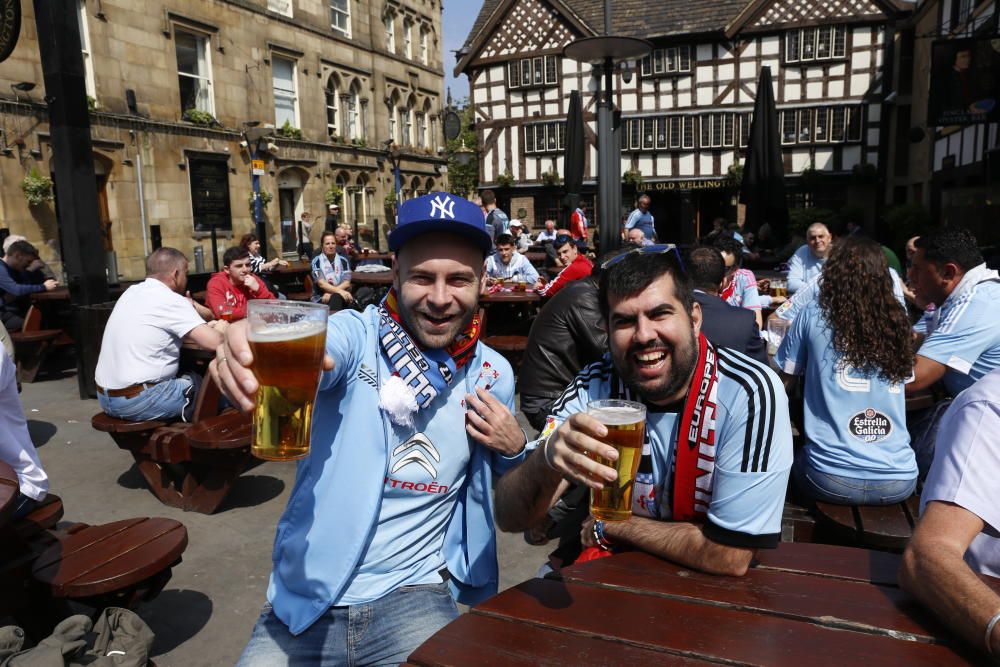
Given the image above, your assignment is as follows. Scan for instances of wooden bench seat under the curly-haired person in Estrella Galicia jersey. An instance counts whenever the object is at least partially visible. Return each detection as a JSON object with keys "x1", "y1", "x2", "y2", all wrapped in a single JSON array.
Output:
[{"x1": 816, "y1": 496, "x2": 920, "y2": 551}]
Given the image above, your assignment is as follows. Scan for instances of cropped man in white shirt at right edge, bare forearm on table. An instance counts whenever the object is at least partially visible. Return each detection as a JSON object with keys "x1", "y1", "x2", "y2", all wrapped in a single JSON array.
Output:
[{"x1": 899, "y1": 370, "x2": 1000, "y2": 664}]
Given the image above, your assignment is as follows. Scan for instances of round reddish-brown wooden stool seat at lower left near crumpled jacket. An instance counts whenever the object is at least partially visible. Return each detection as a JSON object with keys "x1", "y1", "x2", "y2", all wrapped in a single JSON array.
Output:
[{"x1": 32, "y1": 517, "x2": 188, "y2": 610}]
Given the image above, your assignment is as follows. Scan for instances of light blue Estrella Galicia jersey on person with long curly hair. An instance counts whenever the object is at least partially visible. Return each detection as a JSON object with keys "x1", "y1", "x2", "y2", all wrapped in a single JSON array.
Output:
[{"x1": 774, "y1": 300, "x2": 917, "y2": 481}]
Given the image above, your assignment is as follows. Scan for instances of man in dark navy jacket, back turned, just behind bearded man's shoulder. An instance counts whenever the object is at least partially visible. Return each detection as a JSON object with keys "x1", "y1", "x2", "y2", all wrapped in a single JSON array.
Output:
[{"x1": 688, "y1": 247, "x2": 768, "y2": 366}]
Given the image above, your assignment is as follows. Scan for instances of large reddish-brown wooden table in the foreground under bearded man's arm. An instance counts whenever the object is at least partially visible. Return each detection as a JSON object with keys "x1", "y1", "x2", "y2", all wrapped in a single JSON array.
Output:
[{"x1": 409, "y1": 543, "x2": 984, "y2": 667}]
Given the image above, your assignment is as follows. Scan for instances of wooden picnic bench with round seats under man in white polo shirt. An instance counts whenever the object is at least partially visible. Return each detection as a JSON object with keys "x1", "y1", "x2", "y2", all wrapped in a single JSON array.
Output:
[{"x1": 90, "y1": 380, "x2": 252, "y2": 514}]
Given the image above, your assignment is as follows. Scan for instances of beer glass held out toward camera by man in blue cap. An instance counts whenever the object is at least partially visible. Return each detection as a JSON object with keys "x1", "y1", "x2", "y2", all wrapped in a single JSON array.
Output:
[{"x1": 247, "y1": 299, "x2": 330, "y2": 461}]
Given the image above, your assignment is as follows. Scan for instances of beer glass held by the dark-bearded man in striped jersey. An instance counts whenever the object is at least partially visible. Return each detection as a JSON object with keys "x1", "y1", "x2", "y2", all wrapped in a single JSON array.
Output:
[{"x1": 587, "y1": 399, "x2": 646, "y2": 521}]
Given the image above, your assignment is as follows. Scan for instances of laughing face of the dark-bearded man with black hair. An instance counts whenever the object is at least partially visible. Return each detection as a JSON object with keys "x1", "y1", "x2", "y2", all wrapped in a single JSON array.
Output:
[{"x1": 608, "y1": 273, "x2": 701, "y2": 405}]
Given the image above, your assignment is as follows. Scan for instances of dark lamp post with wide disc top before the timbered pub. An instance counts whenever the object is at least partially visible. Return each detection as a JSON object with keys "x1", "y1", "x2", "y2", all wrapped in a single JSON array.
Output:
[{"x1": 563, "y1": 0, "x2": 653, "y2": 252}]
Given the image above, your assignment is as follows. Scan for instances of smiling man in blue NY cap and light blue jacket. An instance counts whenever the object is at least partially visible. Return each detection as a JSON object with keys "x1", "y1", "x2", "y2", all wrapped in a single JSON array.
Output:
[{"x1": 212, "y1": 193, "x2": 526, "y2": 666}]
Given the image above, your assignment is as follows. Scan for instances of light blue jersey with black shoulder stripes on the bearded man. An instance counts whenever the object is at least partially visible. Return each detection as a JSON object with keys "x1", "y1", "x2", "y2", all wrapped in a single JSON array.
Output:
[{"x1": 529, "y1": 348, "x2": 792, "y2": 548}]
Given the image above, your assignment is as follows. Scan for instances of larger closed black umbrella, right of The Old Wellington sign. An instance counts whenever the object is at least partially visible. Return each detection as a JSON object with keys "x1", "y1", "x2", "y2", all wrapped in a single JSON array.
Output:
[{"x1": 740, "y1": 67, "x2": 788, "y2": 238}]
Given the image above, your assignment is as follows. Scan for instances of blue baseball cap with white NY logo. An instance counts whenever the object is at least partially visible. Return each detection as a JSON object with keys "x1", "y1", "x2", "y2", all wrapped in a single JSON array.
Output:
[{"x1": 389, "y1": 192, "x2": 493, "y2": 256}]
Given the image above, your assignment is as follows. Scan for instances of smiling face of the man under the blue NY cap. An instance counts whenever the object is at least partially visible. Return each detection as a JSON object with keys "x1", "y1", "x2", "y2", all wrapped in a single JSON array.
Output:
[{"x1": 393, "y1": 234, "x2": 485, "y2": 349}]
